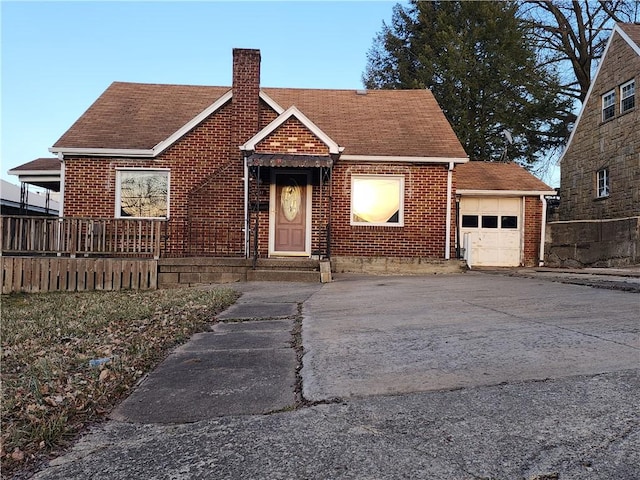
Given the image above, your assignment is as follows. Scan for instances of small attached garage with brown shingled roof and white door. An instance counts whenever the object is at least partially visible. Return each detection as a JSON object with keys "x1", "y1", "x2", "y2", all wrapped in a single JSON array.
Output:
[{"x1": 456, "y1": 162, "x2": 556, "y2": 268}]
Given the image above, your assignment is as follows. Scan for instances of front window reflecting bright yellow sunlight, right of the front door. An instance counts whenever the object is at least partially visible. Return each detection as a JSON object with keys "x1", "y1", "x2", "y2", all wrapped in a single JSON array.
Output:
[{"x1": 351, "y1": 175, "x2": 404, "y2": 227}]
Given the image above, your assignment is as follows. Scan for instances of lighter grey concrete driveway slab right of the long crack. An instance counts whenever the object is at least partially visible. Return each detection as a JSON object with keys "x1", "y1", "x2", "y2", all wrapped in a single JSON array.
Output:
[{"x1": 302, "y1": 272, "x2": 640, "y2": 401}]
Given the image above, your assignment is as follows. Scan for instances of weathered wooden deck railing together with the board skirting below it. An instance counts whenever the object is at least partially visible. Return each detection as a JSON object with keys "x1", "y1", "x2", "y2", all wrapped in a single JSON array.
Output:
[{"x1": 0, "y1": 216, "x2": 166, "y2": 294}]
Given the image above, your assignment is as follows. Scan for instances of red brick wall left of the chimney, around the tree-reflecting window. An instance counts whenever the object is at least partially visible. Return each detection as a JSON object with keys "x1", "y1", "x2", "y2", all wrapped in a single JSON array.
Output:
[{"x1": 64, "y1": 103, "x2": 244, "y2": 254}]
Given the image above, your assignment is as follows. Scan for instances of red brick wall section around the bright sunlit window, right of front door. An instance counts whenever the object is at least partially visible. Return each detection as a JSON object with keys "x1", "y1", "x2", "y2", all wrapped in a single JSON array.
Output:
[{"x1": 332, "y1": 161, "x2": 455, "y2": 259}]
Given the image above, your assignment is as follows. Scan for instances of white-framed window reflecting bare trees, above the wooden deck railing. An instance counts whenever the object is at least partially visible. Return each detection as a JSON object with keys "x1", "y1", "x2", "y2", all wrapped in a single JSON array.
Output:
[{"x1": 116, "y1": 170, "x2": 169, "y2": 218}]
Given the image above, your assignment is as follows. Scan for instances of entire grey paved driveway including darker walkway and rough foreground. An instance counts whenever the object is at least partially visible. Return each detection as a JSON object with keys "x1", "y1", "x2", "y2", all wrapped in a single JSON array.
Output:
[{"x1": 27, "y1": 272, "x2": 640, "y2": 480}]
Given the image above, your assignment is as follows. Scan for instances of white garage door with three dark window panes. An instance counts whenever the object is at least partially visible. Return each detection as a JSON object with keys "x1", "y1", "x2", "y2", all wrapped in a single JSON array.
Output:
[{"x1": 460, "y1": 197, "x2": 522, "y2": 267}]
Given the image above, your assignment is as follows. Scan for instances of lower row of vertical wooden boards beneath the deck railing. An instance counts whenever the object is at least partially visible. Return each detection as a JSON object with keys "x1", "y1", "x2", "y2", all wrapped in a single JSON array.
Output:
[{"x1": 0, "y1": 256, "x2": 158, "y2": 294}]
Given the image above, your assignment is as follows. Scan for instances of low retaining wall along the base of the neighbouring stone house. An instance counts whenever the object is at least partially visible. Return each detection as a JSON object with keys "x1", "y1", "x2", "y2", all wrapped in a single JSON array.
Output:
[{"x1": 545, "y1": 217, "x2": 640, "y2": 267}]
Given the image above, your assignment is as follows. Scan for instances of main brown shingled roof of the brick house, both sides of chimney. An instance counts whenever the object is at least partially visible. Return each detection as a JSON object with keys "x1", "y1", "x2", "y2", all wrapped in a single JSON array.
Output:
[{"x1": 52, "y1": 82, "x2": 467, "y2": 158}]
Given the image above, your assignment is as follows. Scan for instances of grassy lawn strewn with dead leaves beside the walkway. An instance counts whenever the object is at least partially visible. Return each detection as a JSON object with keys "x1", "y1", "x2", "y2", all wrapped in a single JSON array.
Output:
[{"x1": 0, "y1": 288, "x2": 239, "y2": 478}]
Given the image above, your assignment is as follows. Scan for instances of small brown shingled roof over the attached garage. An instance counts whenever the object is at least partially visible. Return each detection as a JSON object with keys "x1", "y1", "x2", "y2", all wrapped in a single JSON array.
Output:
[{"x1": 456, "y1": 162, "x2": 553, "y2": 193}]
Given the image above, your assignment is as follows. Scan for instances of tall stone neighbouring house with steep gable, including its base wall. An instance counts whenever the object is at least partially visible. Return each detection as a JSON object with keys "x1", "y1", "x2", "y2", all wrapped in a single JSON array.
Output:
[{"x1": 547, "y1": 23, "x2": 640, "y2": 266}]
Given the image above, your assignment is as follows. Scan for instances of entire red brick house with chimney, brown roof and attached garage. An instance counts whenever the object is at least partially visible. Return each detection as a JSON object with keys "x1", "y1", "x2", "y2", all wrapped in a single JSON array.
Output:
[{"x1": 5, "y1": 49, "x2": 554, "y2": 272}]
